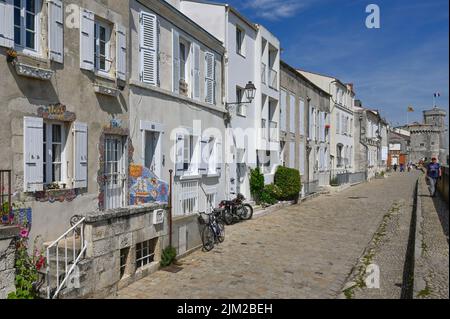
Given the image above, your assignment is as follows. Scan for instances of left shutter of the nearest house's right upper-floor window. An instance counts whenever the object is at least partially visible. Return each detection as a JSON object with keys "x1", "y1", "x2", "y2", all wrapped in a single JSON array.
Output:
[{"x1": 80, "y1": 9, "x2": 95, "y2": 71}]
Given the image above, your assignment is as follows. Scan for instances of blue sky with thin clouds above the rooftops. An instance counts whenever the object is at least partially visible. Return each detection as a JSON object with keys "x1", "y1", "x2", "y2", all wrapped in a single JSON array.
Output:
[{"x1": 228, "y1": 0, "x2": 449, "y2": 129}]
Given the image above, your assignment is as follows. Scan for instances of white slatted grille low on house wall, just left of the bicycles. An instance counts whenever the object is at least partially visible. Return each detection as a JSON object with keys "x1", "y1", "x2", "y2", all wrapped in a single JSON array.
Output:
[{"x1": 174, "y1": 181, "x2": 199, "y2": 216}]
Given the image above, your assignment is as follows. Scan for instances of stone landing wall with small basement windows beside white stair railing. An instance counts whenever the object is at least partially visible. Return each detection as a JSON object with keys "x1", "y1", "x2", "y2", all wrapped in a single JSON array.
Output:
[{"x1": 59, "y1": 204, "x2": 168, "y2": 298}]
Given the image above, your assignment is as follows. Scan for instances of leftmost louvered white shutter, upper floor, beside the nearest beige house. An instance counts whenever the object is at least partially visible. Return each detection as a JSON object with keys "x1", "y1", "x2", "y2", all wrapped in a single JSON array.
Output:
[{"x1": 139, "y1": 12, "x2": 158, "y2": 85}]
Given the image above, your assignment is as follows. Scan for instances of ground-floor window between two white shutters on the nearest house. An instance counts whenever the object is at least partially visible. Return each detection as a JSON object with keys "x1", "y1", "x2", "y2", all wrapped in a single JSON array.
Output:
[{"x1": 42, "y1": 123, "x2": 65, "y2": 188}]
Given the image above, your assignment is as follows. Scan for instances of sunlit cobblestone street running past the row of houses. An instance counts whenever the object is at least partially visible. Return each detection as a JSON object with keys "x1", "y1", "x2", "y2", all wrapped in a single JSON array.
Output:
[{"x1": 113, "y1": 172, "x2": 419, "y2": 299}]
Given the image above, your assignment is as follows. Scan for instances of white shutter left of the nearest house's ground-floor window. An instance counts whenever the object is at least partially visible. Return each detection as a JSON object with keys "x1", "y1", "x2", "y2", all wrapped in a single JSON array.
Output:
[{"x1": 23, "y1": 117, "x2": 44, "y2": 192}]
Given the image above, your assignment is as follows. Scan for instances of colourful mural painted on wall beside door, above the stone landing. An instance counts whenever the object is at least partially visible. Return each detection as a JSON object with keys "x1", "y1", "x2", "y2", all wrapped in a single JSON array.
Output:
[{"x1": 129, "y1": 164, "x2": 169, "y2": 205}]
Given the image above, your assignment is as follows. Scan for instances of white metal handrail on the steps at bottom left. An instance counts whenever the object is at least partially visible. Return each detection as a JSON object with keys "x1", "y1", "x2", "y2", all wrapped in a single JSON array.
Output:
[{"x1": 46, "y1": 217, "x2": 87, "y2": 299}]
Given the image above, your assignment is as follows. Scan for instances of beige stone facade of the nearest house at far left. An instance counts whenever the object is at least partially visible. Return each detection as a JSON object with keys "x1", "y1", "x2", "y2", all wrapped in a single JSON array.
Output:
[{"x1": 0, "y1": 0, "x2": 132, "y2": 242}]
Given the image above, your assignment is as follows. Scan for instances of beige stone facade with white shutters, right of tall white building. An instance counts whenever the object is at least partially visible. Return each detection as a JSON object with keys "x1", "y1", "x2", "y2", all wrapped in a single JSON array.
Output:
[{"x1": 280, "y1": 61, "x2": 330, "y2": 195}]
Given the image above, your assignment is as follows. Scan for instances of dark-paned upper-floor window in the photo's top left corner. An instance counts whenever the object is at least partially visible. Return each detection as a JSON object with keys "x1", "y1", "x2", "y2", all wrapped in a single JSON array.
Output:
[{"x1": 14, "y1": 0, "x2": 39, "y2": 51}]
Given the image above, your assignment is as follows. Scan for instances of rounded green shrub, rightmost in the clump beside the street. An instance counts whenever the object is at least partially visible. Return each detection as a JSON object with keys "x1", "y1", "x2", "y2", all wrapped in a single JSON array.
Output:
[{"x1": 275, "y1": 166, "x2": 302, "y2": 200}]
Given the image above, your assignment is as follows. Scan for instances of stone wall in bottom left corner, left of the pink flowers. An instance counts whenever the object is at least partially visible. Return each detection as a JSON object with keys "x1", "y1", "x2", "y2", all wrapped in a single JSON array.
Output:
[{"x1": 0, "y1": 225, "x2": 19, "y2": 299}]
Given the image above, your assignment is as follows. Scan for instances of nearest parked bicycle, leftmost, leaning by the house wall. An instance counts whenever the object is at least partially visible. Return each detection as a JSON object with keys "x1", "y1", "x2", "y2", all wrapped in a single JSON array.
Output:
[{"x1": 200, "y1": 209, "x2": 225, "y2": 251}]
